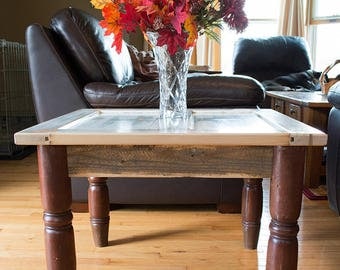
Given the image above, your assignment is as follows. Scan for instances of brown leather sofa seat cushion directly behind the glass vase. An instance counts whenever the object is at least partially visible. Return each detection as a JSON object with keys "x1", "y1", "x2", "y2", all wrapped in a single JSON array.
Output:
[{"x1": 84, "y1": 73, "x2": 264, "y2": 108}]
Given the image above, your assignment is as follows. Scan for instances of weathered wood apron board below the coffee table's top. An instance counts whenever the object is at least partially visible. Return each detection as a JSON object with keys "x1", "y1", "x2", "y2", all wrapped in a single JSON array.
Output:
[{"x1": 67, "y1": 145, "x2": 273, "y2": 178}]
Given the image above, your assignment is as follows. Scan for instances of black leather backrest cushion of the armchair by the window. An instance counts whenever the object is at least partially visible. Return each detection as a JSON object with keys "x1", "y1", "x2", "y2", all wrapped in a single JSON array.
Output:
[{"x1": 233, "y1": 36, "x2": 311, "y2": 82}]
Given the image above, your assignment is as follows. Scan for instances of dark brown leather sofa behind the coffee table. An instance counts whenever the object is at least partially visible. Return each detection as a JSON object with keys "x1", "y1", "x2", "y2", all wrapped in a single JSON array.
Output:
[{"x1": 26, "y1": 8, "x2": 264, "y2": 212}]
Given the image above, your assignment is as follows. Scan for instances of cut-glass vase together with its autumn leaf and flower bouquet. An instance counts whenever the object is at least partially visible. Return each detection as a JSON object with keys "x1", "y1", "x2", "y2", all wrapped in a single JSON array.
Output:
[{"x1": 91, "y1": 0, "x2": 248, "y2": 121}]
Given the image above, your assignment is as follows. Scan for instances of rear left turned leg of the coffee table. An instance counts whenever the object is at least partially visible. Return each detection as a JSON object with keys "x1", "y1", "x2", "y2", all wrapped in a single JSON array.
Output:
[{"x1": 88, "y1": 177, "x2": 110, "y2": 247}]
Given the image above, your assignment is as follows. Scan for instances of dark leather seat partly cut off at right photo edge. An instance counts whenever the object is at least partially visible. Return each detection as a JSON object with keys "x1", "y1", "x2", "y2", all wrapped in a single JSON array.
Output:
[{"x1": 326, "y1": 82, "x2": 340, "y2": 215}]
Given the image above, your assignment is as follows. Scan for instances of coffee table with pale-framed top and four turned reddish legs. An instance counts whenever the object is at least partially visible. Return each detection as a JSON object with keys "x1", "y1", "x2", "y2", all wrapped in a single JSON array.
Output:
[{"x1": 15, "y1": 109, "x2": 327, "y2": 270}]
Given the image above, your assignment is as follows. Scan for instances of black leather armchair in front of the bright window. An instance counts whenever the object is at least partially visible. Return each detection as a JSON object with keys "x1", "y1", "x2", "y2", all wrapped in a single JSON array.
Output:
[{"x1": 233, "y1": 36, "x2": 321, "y2": 101}]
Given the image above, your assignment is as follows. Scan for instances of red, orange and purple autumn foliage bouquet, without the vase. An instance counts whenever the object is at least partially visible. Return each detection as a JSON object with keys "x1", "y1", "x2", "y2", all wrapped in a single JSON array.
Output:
[{"x1": 91, "y1": 0, "x2": 248, "y2": 54}]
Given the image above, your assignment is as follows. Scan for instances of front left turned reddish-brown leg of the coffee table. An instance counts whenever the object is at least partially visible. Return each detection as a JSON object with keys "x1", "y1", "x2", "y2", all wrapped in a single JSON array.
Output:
[{"x1": 37, "y1": 146, "x2": 76, "y2": 270}]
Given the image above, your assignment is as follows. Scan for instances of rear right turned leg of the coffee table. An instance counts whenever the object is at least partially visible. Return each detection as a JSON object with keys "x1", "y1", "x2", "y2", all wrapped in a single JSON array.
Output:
[{"x1": 242, "y1": 178, "x2": 263, "y2": 249}]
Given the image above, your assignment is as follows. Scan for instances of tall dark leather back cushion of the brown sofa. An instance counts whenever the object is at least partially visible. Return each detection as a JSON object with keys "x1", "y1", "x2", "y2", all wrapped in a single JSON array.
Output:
[{"x1": 51, "y1": 8, "x2": 133, "y2": 85}]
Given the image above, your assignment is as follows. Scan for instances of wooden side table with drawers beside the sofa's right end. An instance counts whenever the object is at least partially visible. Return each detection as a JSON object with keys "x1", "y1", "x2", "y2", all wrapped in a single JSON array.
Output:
[{"x1": 266, "y1": 91, "x2": 331, "y2": 188}]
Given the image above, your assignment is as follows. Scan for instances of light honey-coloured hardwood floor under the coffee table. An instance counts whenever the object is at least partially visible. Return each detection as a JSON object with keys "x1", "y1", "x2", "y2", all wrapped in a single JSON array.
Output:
[{"x1": 0, "y1": 154, "x2": 340, "y2": 270}]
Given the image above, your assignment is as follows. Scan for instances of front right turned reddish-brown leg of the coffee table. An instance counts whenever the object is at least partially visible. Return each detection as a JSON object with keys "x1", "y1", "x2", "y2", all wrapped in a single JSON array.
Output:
[{"x1": 267, "y1": 146, "x2": 305, "y2": 270}]
